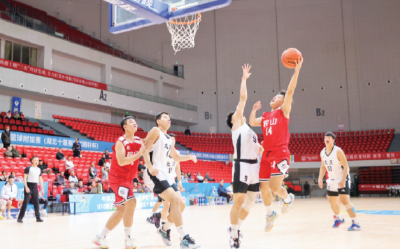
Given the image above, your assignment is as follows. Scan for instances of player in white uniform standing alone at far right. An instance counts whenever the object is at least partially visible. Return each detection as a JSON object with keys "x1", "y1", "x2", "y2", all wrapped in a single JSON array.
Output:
[{"x1": 318, "y1": 132, "x2": 361, "y2": 231}]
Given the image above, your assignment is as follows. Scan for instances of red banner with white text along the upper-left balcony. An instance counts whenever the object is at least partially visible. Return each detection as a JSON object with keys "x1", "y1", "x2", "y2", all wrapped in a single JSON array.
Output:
[{"x1": 0, "y1": 59, "x2": 107, "y2": 90}]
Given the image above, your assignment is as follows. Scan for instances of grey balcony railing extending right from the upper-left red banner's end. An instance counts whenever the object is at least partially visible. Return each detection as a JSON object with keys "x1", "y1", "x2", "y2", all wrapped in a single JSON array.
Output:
[{"x1": 107, "y1": 85, "x2": 197, "y2": 112}]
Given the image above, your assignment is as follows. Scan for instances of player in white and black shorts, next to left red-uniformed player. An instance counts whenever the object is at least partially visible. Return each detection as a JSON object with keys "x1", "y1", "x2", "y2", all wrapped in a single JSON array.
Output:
[{"x1": 143, "y1": 112, "x2": 200, "y2": 248}]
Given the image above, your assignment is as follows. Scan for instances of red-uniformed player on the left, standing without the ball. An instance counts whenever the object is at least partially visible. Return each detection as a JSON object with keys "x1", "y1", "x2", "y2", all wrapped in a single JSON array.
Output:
[{"x1": 93, "y1": 116, "x2": 146, "y2": 249}]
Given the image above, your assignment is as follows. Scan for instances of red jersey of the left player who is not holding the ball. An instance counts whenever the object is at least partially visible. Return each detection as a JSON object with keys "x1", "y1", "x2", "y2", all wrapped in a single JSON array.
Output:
[{"x1": 109, "y1": 136, "x2": 141, "y2": 182}]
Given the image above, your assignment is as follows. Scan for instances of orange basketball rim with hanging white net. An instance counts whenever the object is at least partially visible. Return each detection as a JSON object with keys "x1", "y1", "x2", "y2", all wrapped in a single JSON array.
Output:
[{"x1": 167, "y1": 13, "x2": 201, "y2": 54}]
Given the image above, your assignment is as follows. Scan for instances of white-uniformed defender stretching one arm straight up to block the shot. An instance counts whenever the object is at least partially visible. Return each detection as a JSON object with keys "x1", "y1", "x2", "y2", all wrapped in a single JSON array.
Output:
[{"x1": 226, "y1": 64, "x2": 261, "y2": 248}]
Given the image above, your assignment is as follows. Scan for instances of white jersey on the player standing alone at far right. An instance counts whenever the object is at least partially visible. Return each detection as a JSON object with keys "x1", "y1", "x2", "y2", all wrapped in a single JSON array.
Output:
[{"x1": 321, "y1": 145, "x2": 350, "y2": 182}]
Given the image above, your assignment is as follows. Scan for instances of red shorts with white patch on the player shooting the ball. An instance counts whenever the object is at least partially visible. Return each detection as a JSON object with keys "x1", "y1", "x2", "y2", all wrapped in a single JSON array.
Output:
[{"x1": 260, "y1": 150, "x2": 290, "y2": 182}]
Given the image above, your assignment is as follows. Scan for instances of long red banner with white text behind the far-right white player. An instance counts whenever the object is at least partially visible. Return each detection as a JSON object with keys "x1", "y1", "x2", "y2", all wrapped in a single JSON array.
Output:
[{"x1": 294, "y1": 152, "x2": 400, "y2": 162}]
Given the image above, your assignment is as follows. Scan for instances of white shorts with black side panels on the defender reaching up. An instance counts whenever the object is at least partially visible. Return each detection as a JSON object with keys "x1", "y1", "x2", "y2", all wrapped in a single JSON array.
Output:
[{"x1": 232, "y1": 161, "x2": 260, "y2": 193}]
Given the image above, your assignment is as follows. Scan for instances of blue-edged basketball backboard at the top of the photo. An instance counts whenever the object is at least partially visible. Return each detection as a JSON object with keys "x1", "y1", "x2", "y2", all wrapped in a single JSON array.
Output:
[{"x1": 104, "y1": 0, "x2": 232, "y2": 34}]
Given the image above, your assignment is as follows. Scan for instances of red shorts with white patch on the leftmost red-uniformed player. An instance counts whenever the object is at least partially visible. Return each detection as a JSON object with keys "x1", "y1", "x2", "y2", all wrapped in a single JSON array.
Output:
[{"x1": 110, "y1": 178, "x2": 135, "y2": 205}]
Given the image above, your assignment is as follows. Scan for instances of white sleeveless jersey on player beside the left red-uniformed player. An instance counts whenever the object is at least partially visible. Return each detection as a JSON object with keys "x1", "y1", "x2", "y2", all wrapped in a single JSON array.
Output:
[{"x1": 150, "y1": 128, "x2": 171, "y2": 173}]
